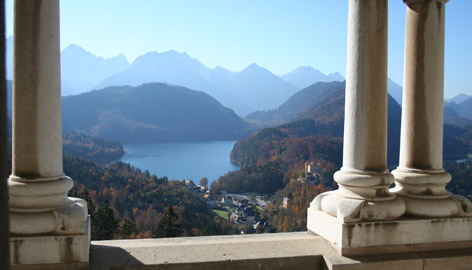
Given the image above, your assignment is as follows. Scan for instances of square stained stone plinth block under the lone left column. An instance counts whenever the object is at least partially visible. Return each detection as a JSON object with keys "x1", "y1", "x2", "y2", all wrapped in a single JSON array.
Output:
[{"x1": 10, "y1": 216, "x2": 90, "y2": 270}]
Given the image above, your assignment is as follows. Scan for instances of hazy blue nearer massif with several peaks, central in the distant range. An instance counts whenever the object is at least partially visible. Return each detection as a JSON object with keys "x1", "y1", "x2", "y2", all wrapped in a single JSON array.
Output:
[{"x1": 92, "y1": 51, "x2": 299, "y2": 115}]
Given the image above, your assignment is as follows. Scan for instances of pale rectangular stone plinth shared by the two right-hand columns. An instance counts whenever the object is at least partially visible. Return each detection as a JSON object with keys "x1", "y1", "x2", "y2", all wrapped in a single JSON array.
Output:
[{"x1": 307, "y1": 207, "x2": 472, "y2": 256}]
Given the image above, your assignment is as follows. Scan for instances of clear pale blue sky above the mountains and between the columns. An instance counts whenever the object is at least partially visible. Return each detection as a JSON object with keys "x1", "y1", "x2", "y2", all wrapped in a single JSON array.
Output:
[{"x1": 6, "y1": 0, "x2": 472, "y2": 97}]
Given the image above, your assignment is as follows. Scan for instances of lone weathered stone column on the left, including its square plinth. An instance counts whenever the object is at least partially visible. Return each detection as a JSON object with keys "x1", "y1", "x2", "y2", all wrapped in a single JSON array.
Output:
[{"x1": 8, "y1": 0, "x2": 88, "y2": 265}]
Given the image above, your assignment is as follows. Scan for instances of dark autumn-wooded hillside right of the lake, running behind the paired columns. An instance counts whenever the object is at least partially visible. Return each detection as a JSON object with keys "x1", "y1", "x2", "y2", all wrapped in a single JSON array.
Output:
[{"x1": 231, "y1": 94, "x2": 401, "y2": 167}]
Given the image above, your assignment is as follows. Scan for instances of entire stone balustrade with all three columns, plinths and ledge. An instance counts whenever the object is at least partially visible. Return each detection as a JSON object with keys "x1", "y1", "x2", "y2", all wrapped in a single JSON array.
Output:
[{"x1": 2, "y1": 0, "x2": 472, "y2": 269}]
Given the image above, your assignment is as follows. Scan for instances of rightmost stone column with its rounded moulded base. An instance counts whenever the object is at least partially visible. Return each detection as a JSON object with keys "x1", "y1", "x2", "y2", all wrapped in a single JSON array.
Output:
[{"x1": 392, "y1": 0, "x2": 471, "y2": 218}]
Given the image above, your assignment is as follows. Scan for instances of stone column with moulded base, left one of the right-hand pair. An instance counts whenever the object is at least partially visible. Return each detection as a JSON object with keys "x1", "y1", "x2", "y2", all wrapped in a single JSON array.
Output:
[{"x1": 312, "y1": 0, "x2": 405, "y2": 222}]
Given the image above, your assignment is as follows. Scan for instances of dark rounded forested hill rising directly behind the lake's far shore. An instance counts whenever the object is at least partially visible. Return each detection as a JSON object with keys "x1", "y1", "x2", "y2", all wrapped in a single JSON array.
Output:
[{"x1": 62, "y1": 83, "x2": 255, "y2": 143}]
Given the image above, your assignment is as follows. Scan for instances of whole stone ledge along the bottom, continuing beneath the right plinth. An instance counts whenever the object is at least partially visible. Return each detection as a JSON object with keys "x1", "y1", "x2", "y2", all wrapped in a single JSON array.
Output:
[{"x1": 90, "y1": 232, "x2": 472, "y2": 270}]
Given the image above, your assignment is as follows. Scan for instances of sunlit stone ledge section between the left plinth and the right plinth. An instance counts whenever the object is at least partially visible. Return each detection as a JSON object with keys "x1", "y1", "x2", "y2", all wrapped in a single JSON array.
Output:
[{"x1": 90, "y1": 232, "x2": 328, "y2": 270}]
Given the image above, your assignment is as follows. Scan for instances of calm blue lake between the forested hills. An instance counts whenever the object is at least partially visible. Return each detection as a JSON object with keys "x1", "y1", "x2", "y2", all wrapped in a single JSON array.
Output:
[{"x1": 121, "y1": 141, "x2": 239, "y2": 185}]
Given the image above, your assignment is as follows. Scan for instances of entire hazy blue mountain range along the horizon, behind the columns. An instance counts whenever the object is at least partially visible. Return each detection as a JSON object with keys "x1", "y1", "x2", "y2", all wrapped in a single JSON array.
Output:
[{"x1": 6, "y1": 36, "x2": 412, "y2": 116}]
